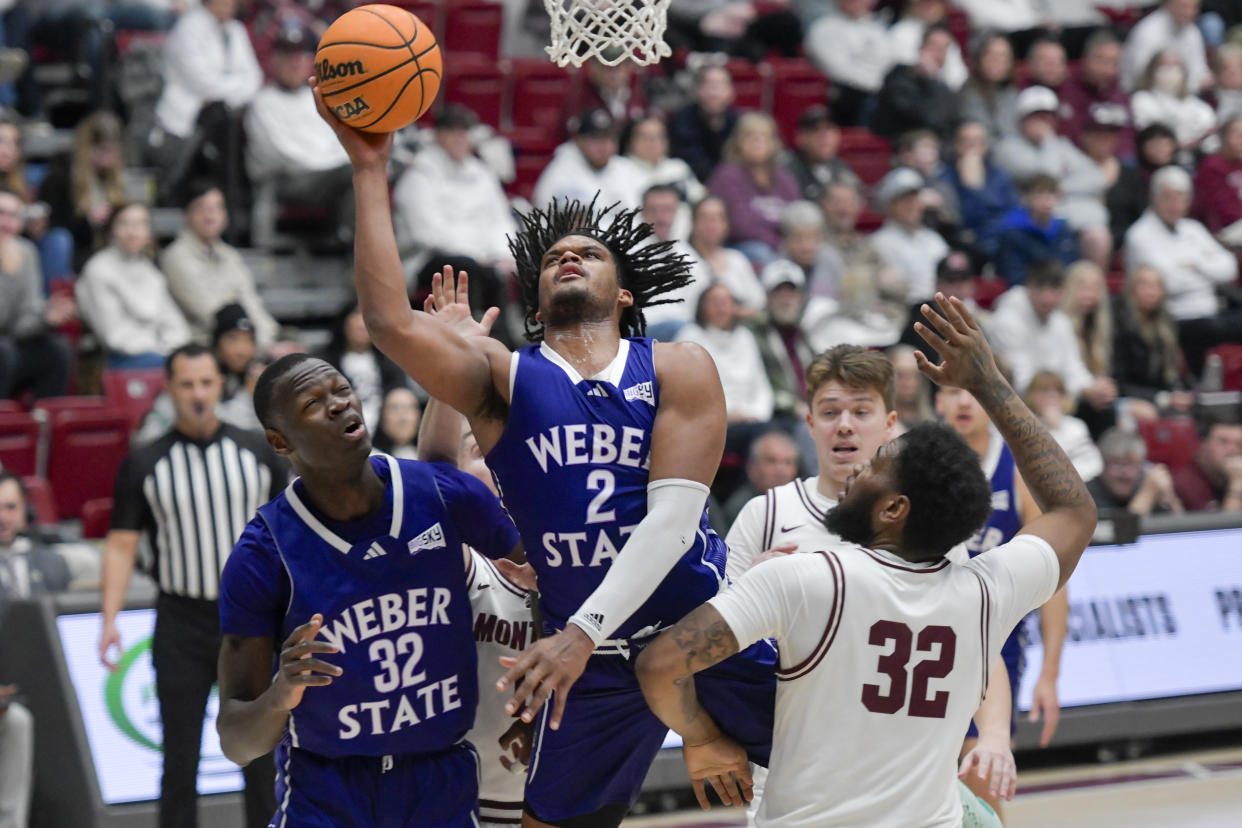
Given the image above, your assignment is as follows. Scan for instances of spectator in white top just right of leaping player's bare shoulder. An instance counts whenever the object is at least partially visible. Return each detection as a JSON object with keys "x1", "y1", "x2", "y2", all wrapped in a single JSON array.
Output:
[{"x1": 677, "y1": 284, "x2": 773, "y2": 424}]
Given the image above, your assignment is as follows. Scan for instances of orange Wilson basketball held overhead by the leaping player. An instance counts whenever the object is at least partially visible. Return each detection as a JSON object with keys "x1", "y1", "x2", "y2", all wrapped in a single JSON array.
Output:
[{"x1": 314, "y1": 4, "x2": 443, "y2": 133}]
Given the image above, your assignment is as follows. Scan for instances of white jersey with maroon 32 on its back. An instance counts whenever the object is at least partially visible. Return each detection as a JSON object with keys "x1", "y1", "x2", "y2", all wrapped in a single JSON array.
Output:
[{"x1": 710, "y1": 535, "x2": 1059, "y2": 828}]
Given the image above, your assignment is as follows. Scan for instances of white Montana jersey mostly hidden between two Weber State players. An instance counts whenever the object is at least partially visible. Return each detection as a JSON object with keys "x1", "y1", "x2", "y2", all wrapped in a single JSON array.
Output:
[{"x1": 466, "y1": 550, "x2": 535, "y2": 826}]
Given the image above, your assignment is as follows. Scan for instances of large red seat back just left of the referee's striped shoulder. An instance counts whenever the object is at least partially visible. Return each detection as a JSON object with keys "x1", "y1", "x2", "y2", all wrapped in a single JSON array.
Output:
[{"x1": 47, "y1": 407, "x2": 129, "y2": 518}]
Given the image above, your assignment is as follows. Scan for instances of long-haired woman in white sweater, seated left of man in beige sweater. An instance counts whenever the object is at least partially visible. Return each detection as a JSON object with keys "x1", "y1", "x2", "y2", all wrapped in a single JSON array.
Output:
[{"x1": 76, "y1": 204, "x2": 191, "y2": 370}]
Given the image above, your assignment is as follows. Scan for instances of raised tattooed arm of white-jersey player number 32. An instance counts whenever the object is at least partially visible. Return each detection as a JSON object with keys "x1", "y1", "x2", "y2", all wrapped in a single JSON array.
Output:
[{"x1": 914, "y1": 293, "x2": 1097, "y2": 587}]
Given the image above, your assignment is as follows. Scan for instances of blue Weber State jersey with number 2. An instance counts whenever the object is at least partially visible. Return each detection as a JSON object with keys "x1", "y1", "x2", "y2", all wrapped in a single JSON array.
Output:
[{"x1": 487, "y1": 338, "x2": 725, "y2": 638}]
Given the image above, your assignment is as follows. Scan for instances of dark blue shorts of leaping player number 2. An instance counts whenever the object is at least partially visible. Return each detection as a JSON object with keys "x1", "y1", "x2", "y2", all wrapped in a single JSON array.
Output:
[{"x1": 516, "y1": 639, "x2": 776, "y2": 822}]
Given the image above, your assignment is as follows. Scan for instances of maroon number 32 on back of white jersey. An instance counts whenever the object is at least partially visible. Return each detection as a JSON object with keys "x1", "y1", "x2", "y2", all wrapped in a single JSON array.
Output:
[{"x1": 862, "y1": 621, "x2": 958, "y2": 719}]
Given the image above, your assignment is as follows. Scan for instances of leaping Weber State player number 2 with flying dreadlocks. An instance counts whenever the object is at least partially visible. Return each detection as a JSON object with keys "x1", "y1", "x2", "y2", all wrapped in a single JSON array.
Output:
[{"x1": 317, "y1": 87, "x2": 775, "y2": 828}]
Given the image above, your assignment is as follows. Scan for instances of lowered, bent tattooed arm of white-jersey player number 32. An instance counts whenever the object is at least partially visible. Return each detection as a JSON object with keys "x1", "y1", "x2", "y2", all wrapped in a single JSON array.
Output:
[{"x1": 636, "y1": 603, "x2": 753, "y2": 808}]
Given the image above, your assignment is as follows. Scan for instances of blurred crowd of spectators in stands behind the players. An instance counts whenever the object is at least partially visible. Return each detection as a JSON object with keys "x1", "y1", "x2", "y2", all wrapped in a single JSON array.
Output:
[{"x1": 0, "y1": 0, "x2": 1242, "y2": 593}]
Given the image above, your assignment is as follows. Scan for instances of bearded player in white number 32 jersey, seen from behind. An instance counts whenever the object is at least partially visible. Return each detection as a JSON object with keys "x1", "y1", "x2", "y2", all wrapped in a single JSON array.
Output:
[{"x1": 638, "y1": 294, "x2": 1095, "y2": 828}]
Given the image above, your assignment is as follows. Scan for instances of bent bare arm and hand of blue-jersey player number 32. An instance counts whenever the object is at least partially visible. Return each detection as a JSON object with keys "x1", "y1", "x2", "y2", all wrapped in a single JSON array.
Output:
[{"x1": 216, "y1": 613, "x2": 340, "y2": 765}]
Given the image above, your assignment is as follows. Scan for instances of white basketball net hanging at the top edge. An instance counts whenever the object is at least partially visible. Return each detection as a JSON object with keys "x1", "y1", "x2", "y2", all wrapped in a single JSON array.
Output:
[{"x1": 544, "y1": 0, "x2": 672, "y2": 66}]
